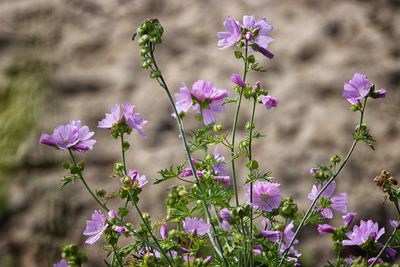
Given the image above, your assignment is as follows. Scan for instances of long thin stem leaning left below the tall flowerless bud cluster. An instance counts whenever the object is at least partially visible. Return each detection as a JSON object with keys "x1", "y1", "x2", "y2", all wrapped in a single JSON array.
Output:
[{"x1": 150, "y1": 46, "x2": 229, "y2": 266}]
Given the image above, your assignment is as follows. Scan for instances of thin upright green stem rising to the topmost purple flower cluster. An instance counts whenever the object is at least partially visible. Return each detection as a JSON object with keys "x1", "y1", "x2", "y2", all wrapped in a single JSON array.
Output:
[{"x1": 231, "y1": 41, "x2": 248, "y2": 207}]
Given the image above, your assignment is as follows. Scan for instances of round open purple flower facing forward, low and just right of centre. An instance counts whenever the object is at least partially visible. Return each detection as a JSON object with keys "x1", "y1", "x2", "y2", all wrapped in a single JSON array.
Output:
[{"x1": 246, "y1": 181, "x2": 282, "y2": 211}]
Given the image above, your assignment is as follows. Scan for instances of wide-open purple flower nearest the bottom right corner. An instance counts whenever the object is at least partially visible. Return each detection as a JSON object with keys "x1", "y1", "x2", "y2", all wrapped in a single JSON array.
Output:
[{"x1": 342, "y1": 220, "x2": 385, "y2": 246}]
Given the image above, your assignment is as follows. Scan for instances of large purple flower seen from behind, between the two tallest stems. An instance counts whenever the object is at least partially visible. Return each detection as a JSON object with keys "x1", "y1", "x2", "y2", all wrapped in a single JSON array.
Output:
[{"x1": 175, "y1": 80, "x2": 228, "y2": 125}]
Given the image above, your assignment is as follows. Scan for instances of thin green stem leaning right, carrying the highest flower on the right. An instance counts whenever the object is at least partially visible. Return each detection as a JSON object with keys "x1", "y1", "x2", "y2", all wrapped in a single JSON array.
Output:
[{"x1": 278, "y1": 98, "x2": 367, "y2": 267}]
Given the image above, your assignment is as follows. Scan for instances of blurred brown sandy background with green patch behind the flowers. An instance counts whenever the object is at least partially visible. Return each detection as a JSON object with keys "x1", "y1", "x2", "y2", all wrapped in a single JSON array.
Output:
[{"x1": 0, "y1": 0, "x2": 400, "y2": 267}]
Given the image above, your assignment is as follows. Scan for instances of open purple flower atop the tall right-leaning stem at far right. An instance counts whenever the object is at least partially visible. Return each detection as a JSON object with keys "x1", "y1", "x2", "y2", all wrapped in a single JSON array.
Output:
[{"x1": 343, "y1": 73, "x2": 371, "y2": 105}]
